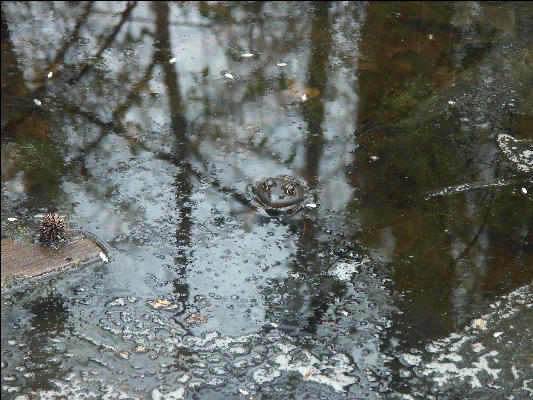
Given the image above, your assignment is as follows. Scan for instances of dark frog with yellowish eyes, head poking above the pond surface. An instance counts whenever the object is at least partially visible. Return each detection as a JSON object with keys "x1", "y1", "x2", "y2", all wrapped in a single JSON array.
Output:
[{"x1": 246, "y1": 175, "x2": 316, "y2": 215}]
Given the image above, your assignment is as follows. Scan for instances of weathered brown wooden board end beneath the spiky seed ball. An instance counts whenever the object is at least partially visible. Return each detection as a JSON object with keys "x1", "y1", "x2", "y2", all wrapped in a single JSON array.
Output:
[{"x1": 1, "y1": 232, "x2": 103, "y2": 284}]
